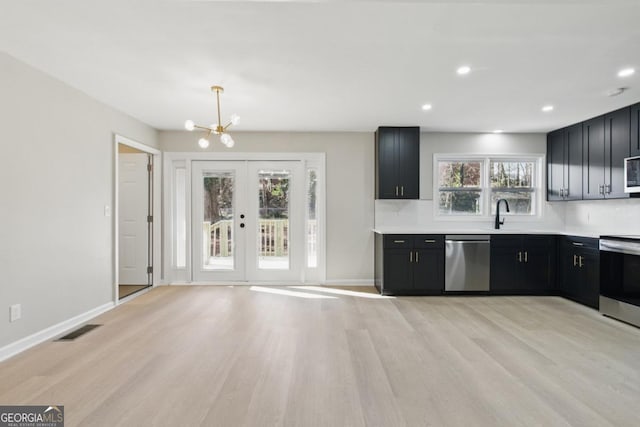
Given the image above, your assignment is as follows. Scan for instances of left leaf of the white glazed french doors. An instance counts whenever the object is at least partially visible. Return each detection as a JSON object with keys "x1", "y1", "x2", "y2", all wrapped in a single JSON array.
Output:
[{"x1": 191, "y1": 161, "x2": 247, "y2": 282}]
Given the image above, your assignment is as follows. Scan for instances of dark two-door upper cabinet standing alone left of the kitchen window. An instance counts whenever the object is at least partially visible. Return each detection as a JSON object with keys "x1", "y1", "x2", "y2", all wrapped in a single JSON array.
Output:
[{"x1": 376, "y1": 126, "x2": 420, "y2": 199}]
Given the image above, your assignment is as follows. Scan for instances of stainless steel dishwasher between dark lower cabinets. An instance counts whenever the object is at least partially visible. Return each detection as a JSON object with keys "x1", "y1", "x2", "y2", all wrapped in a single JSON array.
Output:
[{"x1": 444, "y1": 234, "x2": 491, "y2": 292}]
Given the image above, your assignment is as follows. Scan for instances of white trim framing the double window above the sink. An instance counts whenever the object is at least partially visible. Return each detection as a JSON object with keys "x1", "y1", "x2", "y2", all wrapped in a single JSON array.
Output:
[{"x1": 433, "y1": 153, "x2": 545, "y2": 222}]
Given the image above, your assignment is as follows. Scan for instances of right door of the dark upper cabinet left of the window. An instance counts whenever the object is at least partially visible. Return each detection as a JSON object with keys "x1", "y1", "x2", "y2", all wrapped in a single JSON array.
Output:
[{"x1": 396, "y1": 126, "x2": 420, "y2": 199}]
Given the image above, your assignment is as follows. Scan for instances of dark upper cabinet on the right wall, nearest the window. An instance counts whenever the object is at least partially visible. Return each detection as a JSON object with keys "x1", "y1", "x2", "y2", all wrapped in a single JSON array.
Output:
[{"x1": 547, "y1": 123, "x2": 582, "y2": 201}]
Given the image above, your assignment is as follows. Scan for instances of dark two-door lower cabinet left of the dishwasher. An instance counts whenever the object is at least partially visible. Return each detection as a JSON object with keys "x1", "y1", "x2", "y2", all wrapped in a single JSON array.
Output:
[{"x1": 375, "y1": 233, "x2": 444, "y2": 295}]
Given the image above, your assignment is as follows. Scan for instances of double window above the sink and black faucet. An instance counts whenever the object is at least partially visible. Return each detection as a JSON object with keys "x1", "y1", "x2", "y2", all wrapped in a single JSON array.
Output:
[{"x1": 434, "y1": 154, "x2": 543, "y2": 217}]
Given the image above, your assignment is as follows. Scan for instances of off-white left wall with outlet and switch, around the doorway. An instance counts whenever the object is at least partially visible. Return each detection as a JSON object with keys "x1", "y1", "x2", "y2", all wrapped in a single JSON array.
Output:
[{"x1": 0, "y1": 53, "x2": 157, "y2": 348}]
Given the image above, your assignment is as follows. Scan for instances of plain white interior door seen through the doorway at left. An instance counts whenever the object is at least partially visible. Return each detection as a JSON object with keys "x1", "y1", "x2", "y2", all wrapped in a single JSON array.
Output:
[{"x1": 118, "y1": 153, "x2": 149, "y2": 285}]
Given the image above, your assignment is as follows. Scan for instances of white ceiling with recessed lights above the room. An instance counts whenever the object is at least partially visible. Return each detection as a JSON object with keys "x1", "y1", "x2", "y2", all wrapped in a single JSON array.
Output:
[{"x1": 0, "y1": 0, "x2": 640, "y2": 132}]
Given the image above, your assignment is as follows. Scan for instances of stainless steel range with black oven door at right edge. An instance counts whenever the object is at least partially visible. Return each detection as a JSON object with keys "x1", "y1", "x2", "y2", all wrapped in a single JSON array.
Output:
[{"x1": 600, "y1": 236, "x2": 640, "y2": 327}]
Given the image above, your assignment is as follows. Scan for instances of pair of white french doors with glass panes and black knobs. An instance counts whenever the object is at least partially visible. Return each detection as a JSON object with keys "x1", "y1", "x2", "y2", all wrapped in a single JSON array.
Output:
[{"x1": 191, "y1": 161, "x2": 305, "y2": 282}]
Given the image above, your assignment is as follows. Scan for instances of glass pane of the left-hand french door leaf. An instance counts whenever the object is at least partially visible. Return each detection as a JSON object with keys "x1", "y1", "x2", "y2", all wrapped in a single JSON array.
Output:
[{"x1": 201, "y1": 172, "x2": 235, "y2": 270}]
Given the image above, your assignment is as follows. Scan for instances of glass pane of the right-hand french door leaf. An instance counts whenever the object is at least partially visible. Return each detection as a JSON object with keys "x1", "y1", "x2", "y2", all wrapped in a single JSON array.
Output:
[{"x1": 258, "y1": 170, "x2": 291, "y2": 270}]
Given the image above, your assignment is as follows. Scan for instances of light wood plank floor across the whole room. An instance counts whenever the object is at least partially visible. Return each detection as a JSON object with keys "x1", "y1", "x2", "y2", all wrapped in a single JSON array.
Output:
[{"x1": 0, "y1": 286, "x2": 640, "y2": 427}]
